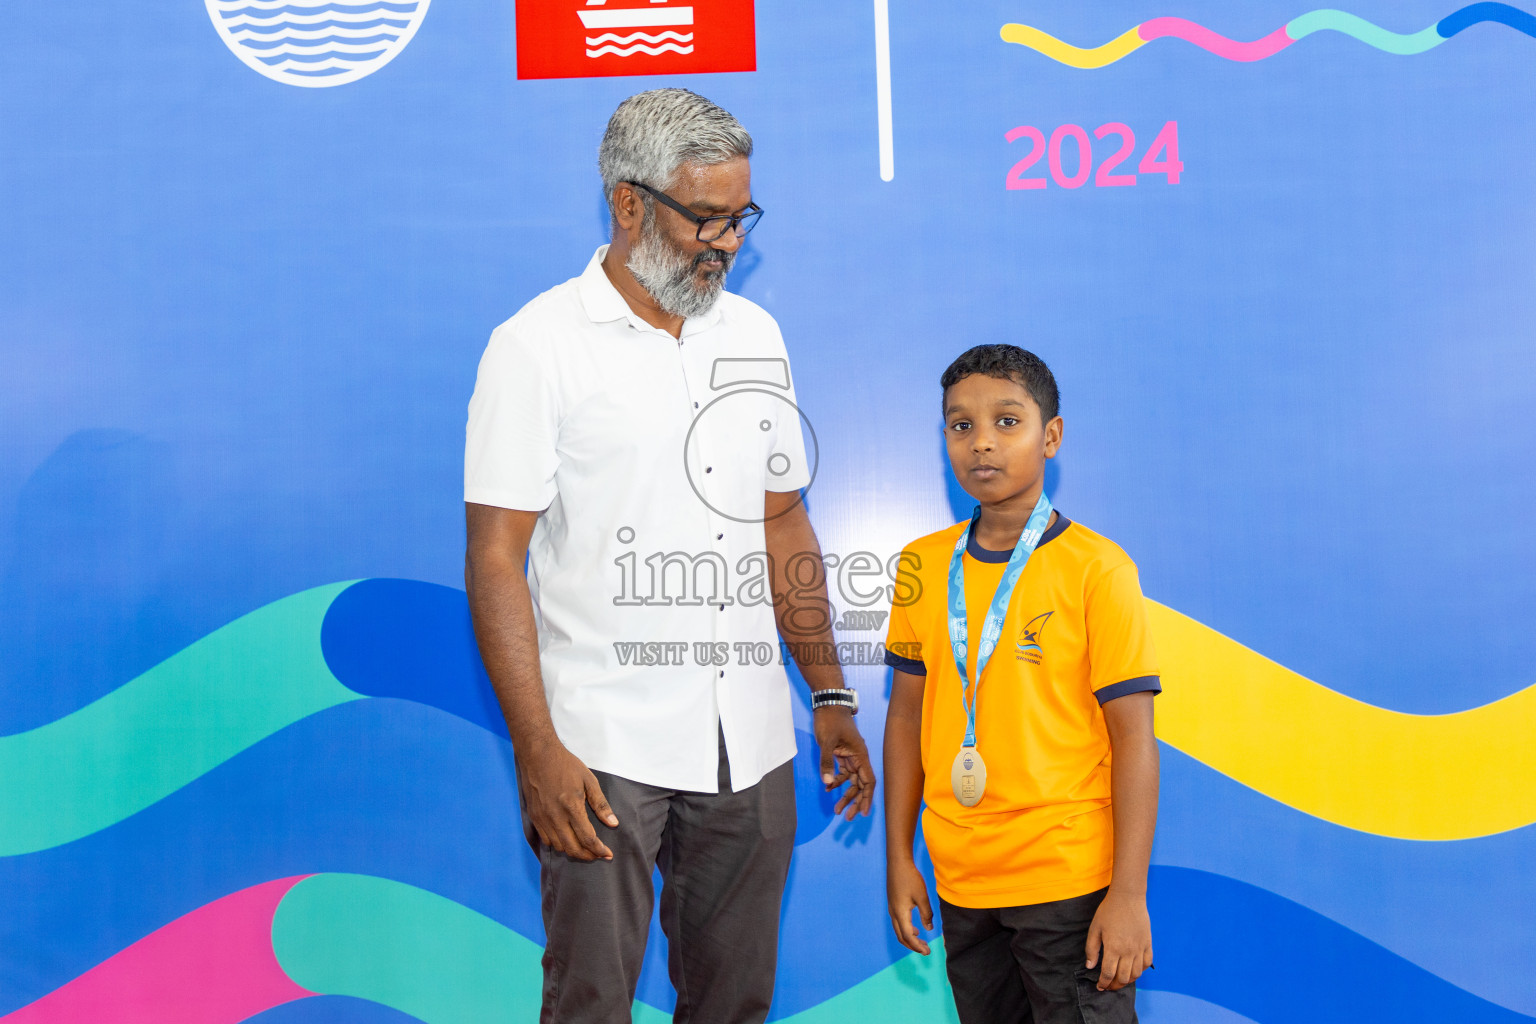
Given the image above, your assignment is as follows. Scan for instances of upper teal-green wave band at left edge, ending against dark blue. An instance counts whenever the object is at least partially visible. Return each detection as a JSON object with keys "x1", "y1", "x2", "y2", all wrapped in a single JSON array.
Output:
[{"x1": 0, "y1": 582, "x2": 359, "y2": 857}]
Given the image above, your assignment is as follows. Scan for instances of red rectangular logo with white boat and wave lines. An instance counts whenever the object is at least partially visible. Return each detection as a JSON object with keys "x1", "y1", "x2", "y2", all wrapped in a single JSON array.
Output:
[{"x1": 518, "y1": 0, "x2": 757, "y2": 78}]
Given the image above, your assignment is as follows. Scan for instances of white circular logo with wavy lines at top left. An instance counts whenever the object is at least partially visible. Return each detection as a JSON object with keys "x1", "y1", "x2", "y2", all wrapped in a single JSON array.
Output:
[{"x1": 203, "y1": 0, "x2": 432, "y2": 89}]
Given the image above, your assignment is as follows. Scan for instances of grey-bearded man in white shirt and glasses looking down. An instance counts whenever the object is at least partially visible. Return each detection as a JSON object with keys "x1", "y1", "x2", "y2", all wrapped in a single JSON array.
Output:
[{"x1": 464, "y1": 89, "x2": 874, "y2": 1024}]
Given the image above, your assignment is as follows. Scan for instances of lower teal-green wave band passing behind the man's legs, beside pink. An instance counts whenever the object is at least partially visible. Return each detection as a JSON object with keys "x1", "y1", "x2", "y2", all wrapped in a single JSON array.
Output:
[{"x1": 272, "y1": 874, "x2": 957, "y2": 1024}]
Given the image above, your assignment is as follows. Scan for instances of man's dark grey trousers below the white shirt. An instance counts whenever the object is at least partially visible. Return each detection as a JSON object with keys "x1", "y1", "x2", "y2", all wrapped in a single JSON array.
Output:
[{"x1": 522, "y1": 737, "x2": 794, "y2": 1024}]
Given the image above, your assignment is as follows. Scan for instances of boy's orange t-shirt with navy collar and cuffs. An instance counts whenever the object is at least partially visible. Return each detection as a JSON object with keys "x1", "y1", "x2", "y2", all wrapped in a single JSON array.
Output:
[{"x1": 886, "y1": 513, "x2": 1161, "y2": 907}]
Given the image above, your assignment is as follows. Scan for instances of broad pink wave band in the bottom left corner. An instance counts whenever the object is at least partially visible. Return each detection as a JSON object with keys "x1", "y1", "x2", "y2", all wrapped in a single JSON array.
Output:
[{"x1": 0, "y1": 875, "x2": 315, "y2": 1024}]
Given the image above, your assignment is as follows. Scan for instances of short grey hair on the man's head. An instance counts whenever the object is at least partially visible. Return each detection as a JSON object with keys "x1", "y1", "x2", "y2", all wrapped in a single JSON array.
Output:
[{"x1": 598, "y1": 89, "x2": 753, "y2": 213}]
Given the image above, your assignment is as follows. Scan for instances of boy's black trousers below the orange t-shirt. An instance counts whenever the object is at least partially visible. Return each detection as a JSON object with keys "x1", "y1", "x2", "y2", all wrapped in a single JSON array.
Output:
[{"x1": 938, "y1": 889, "x2": 1137, "y2": 1024}]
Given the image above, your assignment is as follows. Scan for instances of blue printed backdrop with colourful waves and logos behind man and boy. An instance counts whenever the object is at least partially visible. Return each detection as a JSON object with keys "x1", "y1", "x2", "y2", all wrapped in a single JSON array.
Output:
[{"x1": 0, "y1": 0, "x2": 1536, "y2": 1024}]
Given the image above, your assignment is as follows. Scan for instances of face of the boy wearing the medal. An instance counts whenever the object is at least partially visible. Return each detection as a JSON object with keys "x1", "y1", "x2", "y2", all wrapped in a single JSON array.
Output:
[{"x1": 945, "y1": 373, "x2": 1061, "y2": 505}]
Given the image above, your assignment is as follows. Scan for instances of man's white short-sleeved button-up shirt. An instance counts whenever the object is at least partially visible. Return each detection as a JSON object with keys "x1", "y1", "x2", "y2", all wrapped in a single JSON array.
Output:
[{"x1": 464, "y1": 247, "x2": 816, "y2": 792}]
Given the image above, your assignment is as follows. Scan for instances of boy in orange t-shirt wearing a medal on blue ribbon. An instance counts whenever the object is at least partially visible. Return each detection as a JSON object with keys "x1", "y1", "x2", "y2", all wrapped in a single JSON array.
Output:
[{"x1": 885, "y1": 345, "x2": 1161, "y2": 1024}]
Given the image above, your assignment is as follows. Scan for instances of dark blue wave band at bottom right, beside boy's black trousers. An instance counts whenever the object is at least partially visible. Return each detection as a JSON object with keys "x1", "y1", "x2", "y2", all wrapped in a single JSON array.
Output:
[{"x1": 1141, "y1": 867, "x2": 1536, "y2": 1024}]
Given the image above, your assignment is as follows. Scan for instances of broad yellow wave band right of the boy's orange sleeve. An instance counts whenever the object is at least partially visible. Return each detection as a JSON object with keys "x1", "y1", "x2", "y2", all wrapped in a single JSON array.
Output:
[{"x1": 1147, "y1": 600, "x2": 1536, "y2": 840}]
